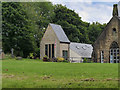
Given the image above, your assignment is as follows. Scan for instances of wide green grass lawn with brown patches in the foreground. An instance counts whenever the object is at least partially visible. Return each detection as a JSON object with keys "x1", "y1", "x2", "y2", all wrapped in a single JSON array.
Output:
[{"x1": 2, "y1": 59, "x2": 118, "y2": 88}]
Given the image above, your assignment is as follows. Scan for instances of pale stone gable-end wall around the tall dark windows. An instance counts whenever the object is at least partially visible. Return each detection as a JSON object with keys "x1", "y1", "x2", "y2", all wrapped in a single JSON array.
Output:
[{"x1": 40, "y1": 25, "x2": 60, "y2": 59}]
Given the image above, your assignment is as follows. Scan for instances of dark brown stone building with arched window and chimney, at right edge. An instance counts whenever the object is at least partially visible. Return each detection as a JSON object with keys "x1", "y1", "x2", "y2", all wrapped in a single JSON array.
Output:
[{"x1": 93, "y1": 4, "x2": 120, "y2": 63}]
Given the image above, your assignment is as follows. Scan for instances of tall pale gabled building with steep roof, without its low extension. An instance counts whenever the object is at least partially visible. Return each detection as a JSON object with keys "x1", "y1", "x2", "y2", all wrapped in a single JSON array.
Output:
[{"x1": 40, "y1": 23, "x2": 70, "y2": 59}]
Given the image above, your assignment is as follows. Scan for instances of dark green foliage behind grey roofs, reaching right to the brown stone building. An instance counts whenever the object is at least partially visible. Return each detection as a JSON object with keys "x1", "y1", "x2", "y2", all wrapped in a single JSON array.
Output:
[{"x1": 53, "y1": 4, "x2": 106, "y2": 44}]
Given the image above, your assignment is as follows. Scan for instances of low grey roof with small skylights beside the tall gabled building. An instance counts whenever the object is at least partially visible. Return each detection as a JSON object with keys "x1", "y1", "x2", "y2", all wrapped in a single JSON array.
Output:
[{"x1": 70, "y1": 42, "x2": 93, "y2": 58}]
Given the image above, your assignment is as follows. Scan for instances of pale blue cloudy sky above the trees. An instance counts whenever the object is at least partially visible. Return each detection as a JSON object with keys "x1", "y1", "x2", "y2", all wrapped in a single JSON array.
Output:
[{"x1": 49, "y1": 0, "x2": 119, "y2": 24}]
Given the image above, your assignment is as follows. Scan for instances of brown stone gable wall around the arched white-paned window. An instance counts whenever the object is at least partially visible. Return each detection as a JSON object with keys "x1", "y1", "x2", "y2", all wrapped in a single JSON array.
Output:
[{"x1": 93, "y1": 16, "x2": 120, "y2": 63}]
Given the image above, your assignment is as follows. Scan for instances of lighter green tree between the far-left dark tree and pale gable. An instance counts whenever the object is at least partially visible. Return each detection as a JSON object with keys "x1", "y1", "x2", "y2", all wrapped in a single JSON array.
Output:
[{"x1": 22, "y1": 2, "x2": 54, "y2": 57}]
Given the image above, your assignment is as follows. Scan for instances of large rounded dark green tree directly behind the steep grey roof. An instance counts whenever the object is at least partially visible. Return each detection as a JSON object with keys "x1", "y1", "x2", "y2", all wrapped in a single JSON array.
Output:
[{"x1": 53, "y1": 4, "x2": 89, "y2": 43}]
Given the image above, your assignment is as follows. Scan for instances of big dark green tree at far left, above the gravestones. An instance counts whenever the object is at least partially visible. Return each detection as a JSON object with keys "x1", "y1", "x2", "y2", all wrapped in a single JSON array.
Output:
[{"x1": 2, "y1": 2, "x2": 35, "y2": 57}]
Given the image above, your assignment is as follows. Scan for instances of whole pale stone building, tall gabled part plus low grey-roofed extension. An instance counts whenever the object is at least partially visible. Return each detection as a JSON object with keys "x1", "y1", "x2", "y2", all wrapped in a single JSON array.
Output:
[{"x1": 40, "y1": 23, "x2": 93, "y2": 62}]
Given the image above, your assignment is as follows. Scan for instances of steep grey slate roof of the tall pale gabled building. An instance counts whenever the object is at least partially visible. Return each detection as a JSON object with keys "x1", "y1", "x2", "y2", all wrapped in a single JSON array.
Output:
[{"x1": 50, "y1": 23, "x2": 70, "y2": 43}]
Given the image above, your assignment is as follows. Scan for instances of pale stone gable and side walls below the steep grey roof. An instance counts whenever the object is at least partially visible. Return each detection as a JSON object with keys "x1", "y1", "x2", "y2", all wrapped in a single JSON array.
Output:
[{"x1": 40, "y1": 25, "x2": 69, "y2": 59}]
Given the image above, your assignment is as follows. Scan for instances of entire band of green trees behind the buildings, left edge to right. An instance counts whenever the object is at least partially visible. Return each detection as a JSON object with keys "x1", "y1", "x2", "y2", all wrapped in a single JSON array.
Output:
[{"x1": 2, "y1": 2, "x2": 106, "y2": 57}]
